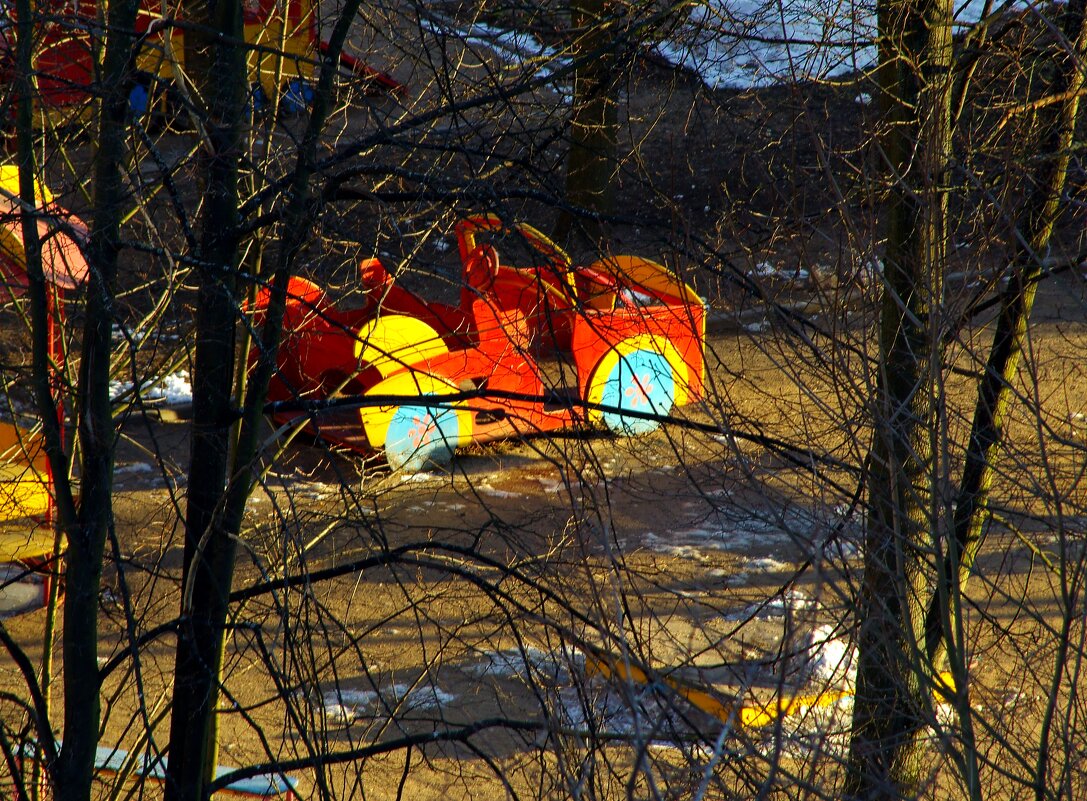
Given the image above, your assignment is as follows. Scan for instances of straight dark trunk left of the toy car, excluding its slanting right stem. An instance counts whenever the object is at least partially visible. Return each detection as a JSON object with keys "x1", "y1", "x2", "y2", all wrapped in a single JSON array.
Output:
[{"x1": 165, "y1": 0, "x2": 247, "y2": 801}]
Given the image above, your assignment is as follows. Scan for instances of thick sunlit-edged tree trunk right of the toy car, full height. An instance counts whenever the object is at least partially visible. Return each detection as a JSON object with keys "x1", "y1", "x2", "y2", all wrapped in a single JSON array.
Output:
[{"x1": 845, "y1": 0, "x2": 952, "y2": 786}]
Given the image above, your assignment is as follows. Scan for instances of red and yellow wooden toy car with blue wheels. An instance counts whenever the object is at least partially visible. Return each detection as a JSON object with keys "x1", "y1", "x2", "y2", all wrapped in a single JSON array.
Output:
[{"x1": 255, "y1": 215, "x2": 704, "y2": 470}]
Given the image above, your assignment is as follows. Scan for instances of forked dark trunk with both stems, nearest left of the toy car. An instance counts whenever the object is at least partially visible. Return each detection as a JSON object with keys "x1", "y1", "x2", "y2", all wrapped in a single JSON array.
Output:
[{"x1": 160, "y1": 0, "x2": 360, "y2": 801}]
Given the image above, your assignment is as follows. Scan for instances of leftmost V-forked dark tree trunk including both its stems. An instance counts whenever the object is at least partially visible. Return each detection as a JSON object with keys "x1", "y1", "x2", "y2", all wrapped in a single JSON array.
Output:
[{"x1": 17, "y1": 0, "x2": 138, "y2": 801}]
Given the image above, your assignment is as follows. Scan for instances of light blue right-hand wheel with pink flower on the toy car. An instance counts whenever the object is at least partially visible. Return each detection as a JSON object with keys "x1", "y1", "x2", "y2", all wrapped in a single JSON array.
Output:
[{"x1": 600, "y1": 350, "x2": 676, "y2": 436}]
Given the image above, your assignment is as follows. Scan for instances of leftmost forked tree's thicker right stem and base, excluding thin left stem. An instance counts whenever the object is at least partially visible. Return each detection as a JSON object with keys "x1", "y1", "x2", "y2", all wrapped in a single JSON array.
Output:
[{"x1": 36, "y1": 0, "x2": 138, "y2": 801}]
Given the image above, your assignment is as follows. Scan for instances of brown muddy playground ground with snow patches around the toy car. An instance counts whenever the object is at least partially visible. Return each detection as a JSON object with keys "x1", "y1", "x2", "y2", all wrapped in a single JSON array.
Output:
[{"x1": 0, "y1": 3, "x2": 1087, "y2": 799}]
